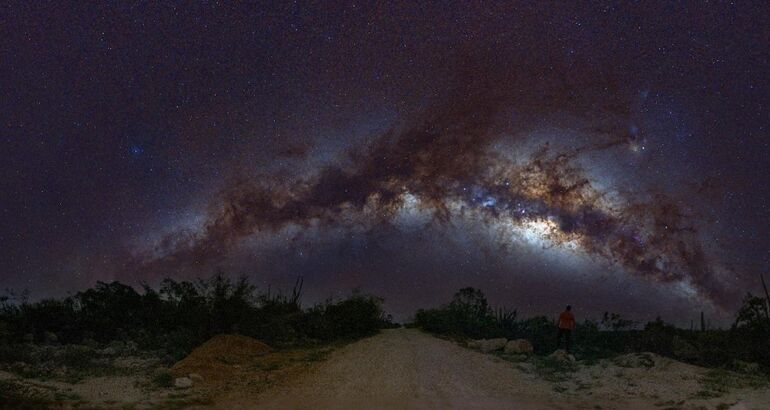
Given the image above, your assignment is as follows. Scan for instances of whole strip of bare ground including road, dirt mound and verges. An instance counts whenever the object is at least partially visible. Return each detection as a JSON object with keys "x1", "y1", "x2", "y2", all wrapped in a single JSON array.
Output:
[{"x1": 0, "y1": 329, "x2": 770, "y2": 410}]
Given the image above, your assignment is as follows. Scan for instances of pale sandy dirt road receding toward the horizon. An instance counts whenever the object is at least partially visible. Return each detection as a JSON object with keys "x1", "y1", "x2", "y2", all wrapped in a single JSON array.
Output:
[{"x1": 220, "y1": 329, "x2": 571, "y2": 409}]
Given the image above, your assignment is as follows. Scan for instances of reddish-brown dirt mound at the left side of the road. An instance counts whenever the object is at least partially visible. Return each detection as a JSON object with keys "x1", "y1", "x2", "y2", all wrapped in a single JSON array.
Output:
[{"x1": 171, "y1": 335, "x2": 273, "y2": 382}]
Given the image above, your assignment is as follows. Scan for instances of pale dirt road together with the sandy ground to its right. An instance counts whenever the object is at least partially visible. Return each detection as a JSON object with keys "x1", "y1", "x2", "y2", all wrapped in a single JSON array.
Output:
[{"x1": 210, "y1": 329, "x2": 770, "y2": 410}]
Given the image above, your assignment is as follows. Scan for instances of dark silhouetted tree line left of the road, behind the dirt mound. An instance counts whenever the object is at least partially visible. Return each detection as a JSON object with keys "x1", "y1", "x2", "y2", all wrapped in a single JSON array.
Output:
[{"x1": 0, "y1": 274, "x2": 390, "y2": 357}]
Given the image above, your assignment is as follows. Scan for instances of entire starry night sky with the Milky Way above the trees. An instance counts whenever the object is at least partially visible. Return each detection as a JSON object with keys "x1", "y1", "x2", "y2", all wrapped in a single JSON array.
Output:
[{"x1": 0, "y1": 2, "x2": 770, "y2": 325}]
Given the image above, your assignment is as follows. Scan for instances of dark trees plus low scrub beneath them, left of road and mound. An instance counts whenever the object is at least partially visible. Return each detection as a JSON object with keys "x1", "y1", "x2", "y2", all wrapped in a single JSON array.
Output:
[{"x1": 0, "y1": 273, "x2": 393, "y2": 408}]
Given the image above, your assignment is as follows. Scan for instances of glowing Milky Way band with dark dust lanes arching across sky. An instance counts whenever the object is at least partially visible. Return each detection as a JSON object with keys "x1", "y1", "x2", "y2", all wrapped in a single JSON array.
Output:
[{"x1": 129, "y1": 75, "x2": 735, "y2": 305}]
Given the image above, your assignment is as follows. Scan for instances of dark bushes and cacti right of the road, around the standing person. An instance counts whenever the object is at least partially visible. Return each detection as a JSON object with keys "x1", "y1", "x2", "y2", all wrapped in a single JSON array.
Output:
[{"x1": 413, "y1": 288, "x2": 770, "y2": 372}]
